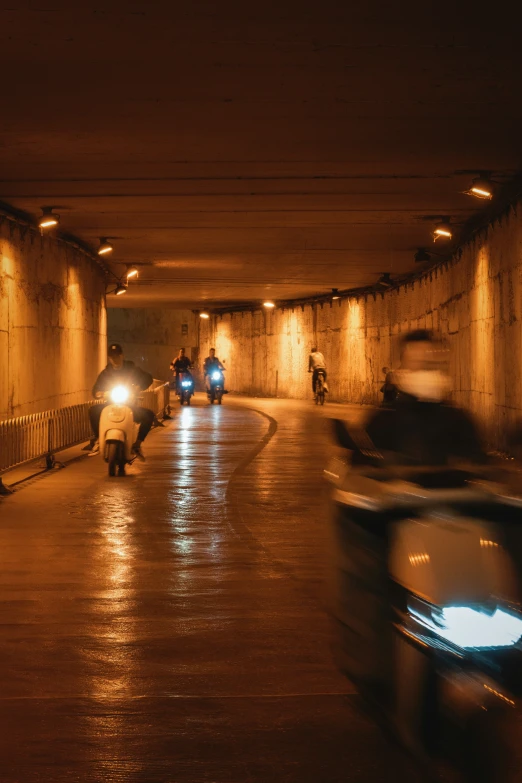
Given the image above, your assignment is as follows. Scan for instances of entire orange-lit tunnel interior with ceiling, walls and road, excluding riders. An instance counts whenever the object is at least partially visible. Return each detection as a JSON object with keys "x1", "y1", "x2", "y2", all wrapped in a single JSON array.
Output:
[{"x1": 0, "y1": 0, "x2": 522, "y2": 783}]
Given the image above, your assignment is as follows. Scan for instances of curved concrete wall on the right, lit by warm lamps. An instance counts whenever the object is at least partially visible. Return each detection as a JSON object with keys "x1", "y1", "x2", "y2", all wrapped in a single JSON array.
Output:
[{"x1": 201, "y1": 207, "x2": 522, "y2": 447}]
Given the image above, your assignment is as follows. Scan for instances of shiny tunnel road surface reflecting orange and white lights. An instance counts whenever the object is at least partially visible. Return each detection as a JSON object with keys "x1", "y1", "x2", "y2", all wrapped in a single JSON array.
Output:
[{"x1": 0, "y1": 398, "x2": 416, "y2": 783}]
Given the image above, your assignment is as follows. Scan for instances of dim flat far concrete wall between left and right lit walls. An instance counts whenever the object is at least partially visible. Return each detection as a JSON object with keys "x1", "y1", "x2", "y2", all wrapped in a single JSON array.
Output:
[{"x1": 107, "y1": 307, "x2": 199, "y2": 380}]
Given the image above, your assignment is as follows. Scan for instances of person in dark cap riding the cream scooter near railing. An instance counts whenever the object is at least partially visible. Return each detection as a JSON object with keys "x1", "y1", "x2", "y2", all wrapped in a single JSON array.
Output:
[{"x1": 89, "y1": 343, "x2": 154, "y2": 460}]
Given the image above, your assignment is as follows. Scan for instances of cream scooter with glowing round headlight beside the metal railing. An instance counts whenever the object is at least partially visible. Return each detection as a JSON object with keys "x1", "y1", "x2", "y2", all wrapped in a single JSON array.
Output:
[{"x1": 100, "y1": 386, "x2": 138, "y2": 476}]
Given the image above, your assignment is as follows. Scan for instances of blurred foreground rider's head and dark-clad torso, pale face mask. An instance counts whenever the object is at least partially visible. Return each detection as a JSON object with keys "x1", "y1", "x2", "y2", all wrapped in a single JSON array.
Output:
[{"x1": 355, "y1": 329, "x2": 486, "y2": 466}]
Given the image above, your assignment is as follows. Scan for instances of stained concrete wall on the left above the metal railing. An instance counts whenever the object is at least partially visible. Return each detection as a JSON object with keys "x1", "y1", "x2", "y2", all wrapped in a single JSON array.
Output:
[{"x1": 0, "y1": 218, "x2": 106, "y2": 418}]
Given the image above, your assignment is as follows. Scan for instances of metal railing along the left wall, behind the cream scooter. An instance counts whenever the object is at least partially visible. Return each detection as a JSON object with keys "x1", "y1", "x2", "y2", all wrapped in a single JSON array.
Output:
[{"x1": 0, "y1": 380, "x2": 170, "y2": 495}]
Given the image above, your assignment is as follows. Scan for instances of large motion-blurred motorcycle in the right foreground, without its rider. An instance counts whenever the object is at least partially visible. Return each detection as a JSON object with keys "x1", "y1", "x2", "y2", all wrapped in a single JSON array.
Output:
[{"x1": 325, "y1": 420, "x2": 522, "y2": 783}]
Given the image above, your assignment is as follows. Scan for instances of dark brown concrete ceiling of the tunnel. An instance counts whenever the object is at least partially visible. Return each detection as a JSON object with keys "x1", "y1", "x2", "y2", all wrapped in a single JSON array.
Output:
[{"x1": 0, "y1": 0, "x2": 522, "y2": 307}]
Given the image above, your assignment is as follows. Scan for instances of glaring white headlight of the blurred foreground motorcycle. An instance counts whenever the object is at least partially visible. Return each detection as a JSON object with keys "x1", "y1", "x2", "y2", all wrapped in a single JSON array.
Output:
[{"x1": 410, "y1": 606, "x2": 522, "y2": 650}]
